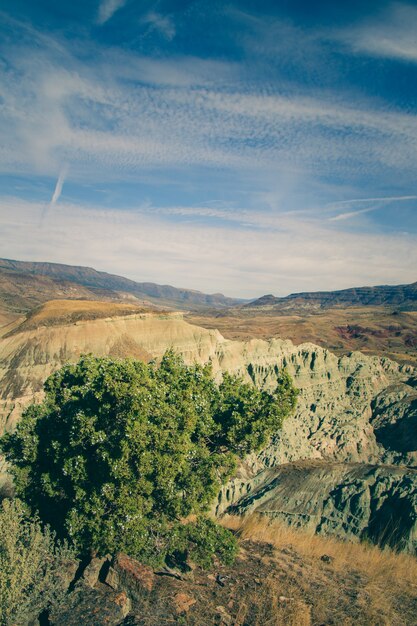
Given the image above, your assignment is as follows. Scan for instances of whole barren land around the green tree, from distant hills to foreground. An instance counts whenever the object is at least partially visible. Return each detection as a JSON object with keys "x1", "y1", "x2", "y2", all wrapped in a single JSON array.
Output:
[{"x1": 0, "y1": 262, "x2": 417, "y2": 626}]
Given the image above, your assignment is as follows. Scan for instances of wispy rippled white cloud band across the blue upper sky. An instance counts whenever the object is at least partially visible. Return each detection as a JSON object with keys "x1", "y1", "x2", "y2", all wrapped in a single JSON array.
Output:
[{"x1": 0, "y1": 16, "x2": 417, "y2": 185}]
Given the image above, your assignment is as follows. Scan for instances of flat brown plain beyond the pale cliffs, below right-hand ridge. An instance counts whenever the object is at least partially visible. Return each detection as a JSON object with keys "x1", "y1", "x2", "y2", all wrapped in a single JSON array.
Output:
[{"x1": 186, "y1": 306, "x2": 417, "y2": 365}]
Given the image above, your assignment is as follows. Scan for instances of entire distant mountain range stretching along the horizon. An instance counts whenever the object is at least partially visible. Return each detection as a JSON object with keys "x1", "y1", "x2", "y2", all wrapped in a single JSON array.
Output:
[{"x1": 0, "y1": 259, "x2": 417, "y2": 320}]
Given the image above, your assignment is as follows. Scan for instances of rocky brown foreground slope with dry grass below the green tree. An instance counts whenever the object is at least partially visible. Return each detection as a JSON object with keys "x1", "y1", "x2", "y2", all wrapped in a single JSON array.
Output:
[{"x1": 44, "y1": 526, "x2": 417, "y2": 626}]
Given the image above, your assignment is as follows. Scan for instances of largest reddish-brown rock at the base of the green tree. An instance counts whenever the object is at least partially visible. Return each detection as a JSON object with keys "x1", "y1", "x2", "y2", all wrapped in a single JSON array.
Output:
[{"x1": 113, "y1": 553, "x2": 155, "y2": 602}]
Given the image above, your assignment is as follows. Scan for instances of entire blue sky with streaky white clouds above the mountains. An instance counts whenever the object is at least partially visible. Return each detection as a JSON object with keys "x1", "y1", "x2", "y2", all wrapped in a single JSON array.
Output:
[{"x1": 0, "y1": 0, "x2": 417, "y2": 298}]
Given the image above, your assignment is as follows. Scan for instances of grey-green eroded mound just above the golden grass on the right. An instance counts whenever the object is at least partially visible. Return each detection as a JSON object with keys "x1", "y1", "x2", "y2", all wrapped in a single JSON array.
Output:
[{"x1": 229, "y1": 461, "x2": 417, "y2": 553}]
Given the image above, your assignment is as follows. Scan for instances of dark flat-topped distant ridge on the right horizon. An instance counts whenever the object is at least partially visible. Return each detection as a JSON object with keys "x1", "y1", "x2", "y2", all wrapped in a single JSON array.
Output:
[{"x1": 243, "y1": 282, "x2": 417, "y2": 310}]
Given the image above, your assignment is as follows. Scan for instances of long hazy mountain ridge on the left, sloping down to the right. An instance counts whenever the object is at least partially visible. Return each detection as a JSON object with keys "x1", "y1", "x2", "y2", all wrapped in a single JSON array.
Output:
[{"x1": 0, "y1": 259, "x2": 243, "y2": 312}]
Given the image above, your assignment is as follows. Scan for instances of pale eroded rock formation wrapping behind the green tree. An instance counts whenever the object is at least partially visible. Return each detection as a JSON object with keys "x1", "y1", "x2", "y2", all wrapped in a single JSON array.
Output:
[{"x1": 0, "y1": 314, "x2": 417, "y2": 547}]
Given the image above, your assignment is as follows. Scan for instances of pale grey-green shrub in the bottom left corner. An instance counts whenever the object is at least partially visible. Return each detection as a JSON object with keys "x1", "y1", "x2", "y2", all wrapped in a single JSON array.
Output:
[{"x1": 0, "y1": 499, "x2": 73, "y2": 626}]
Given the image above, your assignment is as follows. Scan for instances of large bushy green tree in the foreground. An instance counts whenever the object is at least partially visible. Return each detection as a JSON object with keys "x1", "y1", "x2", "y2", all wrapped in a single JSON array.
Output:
[{"x1": 1, "y1": 351, "x2": 296, "y2": 563}]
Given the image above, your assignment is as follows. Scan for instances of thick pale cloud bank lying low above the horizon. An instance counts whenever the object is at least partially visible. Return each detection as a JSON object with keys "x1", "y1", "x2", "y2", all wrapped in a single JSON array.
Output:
[{"x1": 0, "y1": 197, "x2": 417, "y2": 298}]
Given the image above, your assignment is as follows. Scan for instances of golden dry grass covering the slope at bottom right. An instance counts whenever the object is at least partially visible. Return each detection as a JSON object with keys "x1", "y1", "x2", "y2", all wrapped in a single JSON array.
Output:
[{"x1": 218, "y1": 515, "x2": 417, "y2": 626}]
